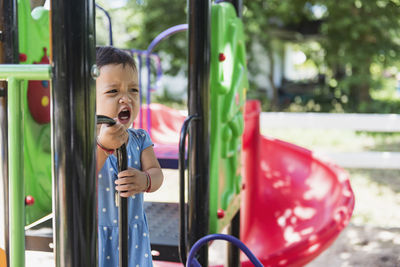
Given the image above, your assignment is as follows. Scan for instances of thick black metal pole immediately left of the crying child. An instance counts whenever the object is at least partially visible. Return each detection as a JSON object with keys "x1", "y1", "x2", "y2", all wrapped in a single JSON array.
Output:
[{"x1": 51, "y1": 0, "x2": 97, "y2": 267}]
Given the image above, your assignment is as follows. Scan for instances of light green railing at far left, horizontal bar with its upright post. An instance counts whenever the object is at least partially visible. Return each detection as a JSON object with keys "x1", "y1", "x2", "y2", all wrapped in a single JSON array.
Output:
[{"x1": 0, "y1": 64, "x2": 51, "y2": 266}]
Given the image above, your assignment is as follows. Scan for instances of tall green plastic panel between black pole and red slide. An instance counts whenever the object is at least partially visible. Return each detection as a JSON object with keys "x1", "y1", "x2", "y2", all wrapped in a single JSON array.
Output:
[{"x1": 210, "y1": 2, "x2": 248, "y2": 236}]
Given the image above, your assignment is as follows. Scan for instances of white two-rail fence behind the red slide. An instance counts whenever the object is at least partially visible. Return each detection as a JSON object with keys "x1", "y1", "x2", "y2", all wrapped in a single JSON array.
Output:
[{"x1": 260, "y1": 112, "x2": 400, "y2": 169}]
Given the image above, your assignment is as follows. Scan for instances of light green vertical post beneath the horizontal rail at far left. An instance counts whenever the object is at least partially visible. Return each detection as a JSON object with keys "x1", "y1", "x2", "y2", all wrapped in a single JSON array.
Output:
[{"x1": 8, "y1": 78, "x2": 25, "y2": 267}]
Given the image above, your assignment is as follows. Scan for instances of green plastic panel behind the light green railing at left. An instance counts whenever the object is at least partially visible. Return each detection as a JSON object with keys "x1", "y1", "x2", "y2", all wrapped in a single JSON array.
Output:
[{"x1": 18, "y1": 0, "x2": 52, "y2": 224}]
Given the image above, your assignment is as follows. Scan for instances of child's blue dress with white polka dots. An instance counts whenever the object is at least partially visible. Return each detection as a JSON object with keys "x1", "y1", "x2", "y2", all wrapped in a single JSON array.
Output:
[{"x1": 98, "y1": 129, "x2": 153, "y2": 267}]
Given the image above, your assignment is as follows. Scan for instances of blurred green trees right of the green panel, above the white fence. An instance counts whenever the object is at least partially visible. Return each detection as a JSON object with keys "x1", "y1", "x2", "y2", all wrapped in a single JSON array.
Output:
[{"x1": 244, "y1": 0, "x2": 400, "y2": 112}]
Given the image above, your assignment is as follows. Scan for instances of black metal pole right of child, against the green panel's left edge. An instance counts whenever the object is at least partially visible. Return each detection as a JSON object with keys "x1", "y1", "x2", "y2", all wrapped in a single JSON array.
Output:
[{"x1": 187, "y1": 0, "x2": 211, "y2": 266}]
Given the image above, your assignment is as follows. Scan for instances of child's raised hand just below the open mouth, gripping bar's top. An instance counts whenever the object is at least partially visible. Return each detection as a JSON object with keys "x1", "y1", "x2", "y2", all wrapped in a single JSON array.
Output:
[{"x1": 97, "y1": 122, "x2": 129, "y2": 149}]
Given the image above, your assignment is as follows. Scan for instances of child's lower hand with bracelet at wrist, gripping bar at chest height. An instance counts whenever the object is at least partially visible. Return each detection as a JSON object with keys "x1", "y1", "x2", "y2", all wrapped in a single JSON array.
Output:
[{"x1": 115, "y1": 168, "x2": 148, "y2": 197}]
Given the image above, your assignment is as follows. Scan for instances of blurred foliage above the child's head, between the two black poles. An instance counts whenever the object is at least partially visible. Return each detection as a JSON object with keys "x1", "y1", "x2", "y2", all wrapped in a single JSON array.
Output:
[{"x1": 96, "y1": 0, "x2": 187, "y2": 75}]
